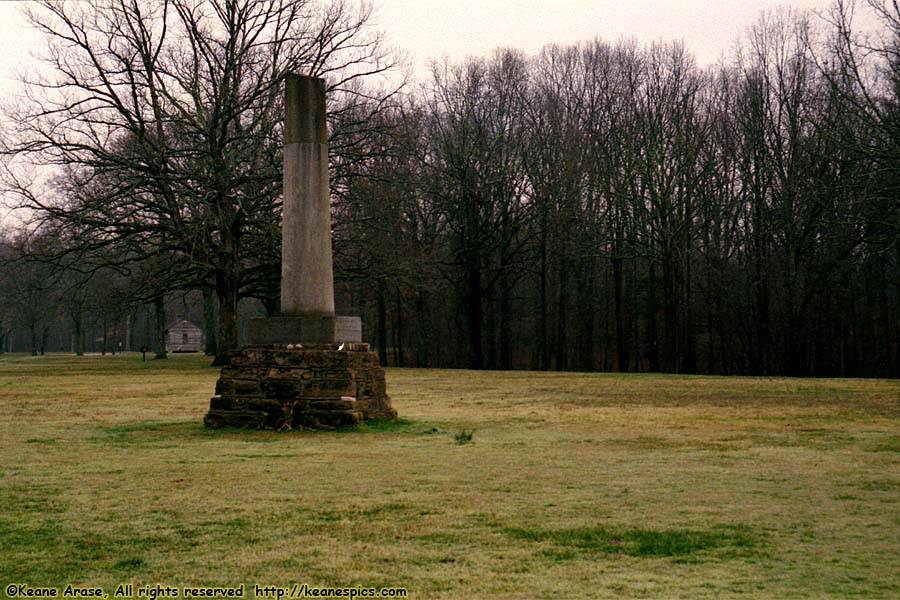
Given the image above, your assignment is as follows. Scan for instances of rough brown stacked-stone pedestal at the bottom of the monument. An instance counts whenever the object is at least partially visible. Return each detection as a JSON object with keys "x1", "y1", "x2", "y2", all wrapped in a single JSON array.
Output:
[{"x1": 209, "y1": 343, "x2": 397, "y2": 429}]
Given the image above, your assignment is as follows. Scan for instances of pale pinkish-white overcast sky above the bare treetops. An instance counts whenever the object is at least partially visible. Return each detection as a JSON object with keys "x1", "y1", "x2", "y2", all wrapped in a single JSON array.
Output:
[{"x1": 0, "y1": 0, "x2": 829, "y2": 91}]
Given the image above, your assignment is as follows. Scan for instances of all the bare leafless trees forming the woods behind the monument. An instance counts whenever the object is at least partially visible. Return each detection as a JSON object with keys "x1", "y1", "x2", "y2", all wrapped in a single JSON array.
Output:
[{"x1": 0, "y1": 0, "x2": 900, "y2": 377}]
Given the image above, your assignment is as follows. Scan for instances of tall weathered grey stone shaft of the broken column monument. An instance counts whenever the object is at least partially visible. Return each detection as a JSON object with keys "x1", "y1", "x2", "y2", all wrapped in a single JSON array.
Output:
[{"x1": 281, "y1": 73, "x2": 334, "y2": 317}]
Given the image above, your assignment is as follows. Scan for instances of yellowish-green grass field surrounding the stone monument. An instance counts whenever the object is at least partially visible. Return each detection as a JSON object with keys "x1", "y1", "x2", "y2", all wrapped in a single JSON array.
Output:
[{"x1": 0, "y1": 355, "x2": 900, "y2": 599}]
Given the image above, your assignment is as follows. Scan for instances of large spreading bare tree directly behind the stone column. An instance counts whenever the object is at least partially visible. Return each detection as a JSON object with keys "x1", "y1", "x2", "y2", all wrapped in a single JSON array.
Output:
[{"x1": 5, "y1": 0, "x2": 394, "y2": 358}]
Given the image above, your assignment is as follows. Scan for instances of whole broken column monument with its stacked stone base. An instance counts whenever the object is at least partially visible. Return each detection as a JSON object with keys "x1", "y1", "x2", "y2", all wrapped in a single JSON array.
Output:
[{"x1": 209, "y1": 74, "x2": 397, "y2": 429}]
